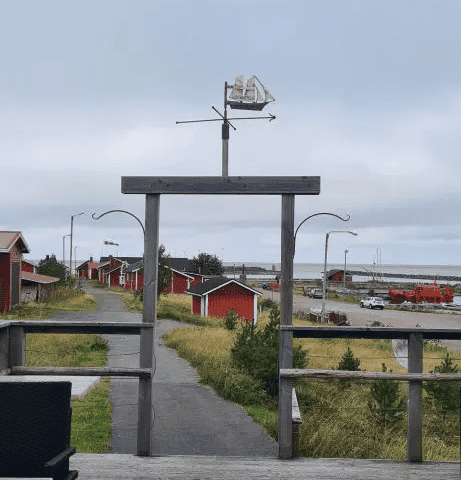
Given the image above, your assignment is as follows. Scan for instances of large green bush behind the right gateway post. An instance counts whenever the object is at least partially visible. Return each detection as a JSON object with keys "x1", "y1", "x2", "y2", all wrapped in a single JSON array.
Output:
[{"x1": 231, "y1": 307, "x2": 308, "y2": 396}]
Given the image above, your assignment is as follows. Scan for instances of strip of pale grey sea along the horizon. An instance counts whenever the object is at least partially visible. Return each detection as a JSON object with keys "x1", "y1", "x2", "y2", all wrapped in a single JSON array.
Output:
[{"x1": 223, "y1": 262, "x2": 461, "y2": 284}]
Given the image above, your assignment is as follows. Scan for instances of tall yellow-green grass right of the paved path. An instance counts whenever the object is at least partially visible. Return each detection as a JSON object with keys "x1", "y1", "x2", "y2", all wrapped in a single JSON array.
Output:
[{"x1": 163, "y1": 306, "x2": 459, "y2": 461}]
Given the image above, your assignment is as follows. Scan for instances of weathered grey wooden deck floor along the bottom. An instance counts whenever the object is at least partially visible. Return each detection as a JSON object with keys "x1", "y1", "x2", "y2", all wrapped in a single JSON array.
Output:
[{"x1": 62, "y1": 453, "x2": 460, "y2": 480}]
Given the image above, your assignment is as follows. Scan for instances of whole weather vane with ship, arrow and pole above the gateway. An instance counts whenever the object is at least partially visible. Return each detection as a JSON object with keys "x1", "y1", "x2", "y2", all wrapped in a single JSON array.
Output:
[{"x1": 176, "y1": 75, "x2": 276, "y2": 177}]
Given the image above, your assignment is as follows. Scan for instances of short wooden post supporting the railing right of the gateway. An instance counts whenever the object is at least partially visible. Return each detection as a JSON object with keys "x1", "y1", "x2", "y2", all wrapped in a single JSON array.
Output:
[{"x1": 408, "y1": 333, "x2": 424, "y2": 462}]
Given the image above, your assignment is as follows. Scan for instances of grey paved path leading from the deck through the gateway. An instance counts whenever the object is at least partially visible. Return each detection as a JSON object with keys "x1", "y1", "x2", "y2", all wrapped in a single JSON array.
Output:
[{"x1": 53, "y1": 284, "x2": 277, "y2": 457}]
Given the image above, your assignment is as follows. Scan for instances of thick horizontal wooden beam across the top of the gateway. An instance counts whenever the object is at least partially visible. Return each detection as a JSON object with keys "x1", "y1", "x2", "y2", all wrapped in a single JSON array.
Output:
[{"x1": 122, "y1": 176, "x2": 320, "y2": 195}]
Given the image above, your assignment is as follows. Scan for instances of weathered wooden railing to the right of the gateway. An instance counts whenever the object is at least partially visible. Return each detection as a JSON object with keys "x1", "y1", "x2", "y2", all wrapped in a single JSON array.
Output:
[{"x1": 278, "y1": 325, "x2": 461, "y2": 462}]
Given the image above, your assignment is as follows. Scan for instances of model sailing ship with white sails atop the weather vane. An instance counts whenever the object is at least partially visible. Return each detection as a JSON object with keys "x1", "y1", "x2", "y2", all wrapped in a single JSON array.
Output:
[{"x1": 226, "y1": 75, "x2": 275, "y2": 111}]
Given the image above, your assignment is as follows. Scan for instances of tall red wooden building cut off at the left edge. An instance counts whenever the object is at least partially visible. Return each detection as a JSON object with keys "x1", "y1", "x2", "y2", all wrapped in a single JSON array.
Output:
[{"x1": 0, "y1": 232, "x2": 29, "y2": 312}]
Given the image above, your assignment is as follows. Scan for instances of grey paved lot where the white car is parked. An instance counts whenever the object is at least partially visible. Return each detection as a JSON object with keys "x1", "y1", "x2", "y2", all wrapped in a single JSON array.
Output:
[{"x1": 263, "y1": 290, "x2": 461, "y2": 351}]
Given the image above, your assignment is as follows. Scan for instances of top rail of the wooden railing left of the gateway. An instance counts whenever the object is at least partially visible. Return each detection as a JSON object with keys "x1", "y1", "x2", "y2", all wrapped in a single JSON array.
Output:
[{"x1": 10, "y1": 320, "x2": 154, "y2": 335}]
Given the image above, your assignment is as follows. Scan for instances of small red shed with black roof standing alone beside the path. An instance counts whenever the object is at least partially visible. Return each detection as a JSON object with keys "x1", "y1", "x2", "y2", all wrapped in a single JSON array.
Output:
[{"x1": 185, "y1": 278, "x2": 261, "y2": 323}]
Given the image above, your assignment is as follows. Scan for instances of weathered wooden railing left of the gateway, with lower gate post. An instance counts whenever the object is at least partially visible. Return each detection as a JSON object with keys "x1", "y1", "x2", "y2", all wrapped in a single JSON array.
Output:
[{"x1": 0, "y1": 320, "x2": 154, "y2": 455}]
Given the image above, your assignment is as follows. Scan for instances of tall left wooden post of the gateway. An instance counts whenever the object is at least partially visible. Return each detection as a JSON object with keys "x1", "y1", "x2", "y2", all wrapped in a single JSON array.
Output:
[{"x1": 137, "y1": 194, "x2": 160, "y2": 456}]
